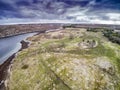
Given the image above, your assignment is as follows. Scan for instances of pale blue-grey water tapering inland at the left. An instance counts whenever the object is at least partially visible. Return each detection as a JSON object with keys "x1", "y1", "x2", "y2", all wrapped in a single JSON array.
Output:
[{"x1": 0, "y1": 33, "x2": 36, "y2": 64}]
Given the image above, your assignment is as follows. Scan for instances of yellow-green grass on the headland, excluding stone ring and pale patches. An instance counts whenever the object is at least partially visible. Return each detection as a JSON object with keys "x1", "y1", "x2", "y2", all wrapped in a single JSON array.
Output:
[{"x1": 9, "y1": 29, "x2": 120, "y2": 90}]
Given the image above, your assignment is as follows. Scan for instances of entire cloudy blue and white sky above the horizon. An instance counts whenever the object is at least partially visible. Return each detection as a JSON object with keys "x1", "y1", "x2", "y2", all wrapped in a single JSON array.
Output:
[{"x1": 0, "y1": 0, "x2": 120, "y2": 24}]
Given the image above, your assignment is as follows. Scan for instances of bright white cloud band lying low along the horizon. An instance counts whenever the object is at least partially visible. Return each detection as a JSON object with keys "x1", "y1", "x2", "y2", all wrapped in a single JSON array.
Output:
[{"x1": 0, "y1": 16, "x2": 120, "y2": 25}]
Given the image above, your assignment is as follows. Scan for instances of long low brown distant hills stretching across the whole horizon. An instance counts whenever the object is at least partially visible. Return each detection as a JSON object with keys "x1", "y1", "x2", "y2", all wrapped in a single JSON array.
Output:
[{"x1": 0, "y1": 23, "x2": 120, "y2": 38}]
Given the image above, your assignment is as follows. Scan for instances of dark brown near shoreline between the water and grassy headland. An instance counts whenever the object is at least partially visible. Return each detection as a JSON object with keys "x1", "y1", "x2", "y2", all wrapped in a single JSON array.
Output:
[{"x1": 0, "y1": 34, "x2": 37, "y2": 90}]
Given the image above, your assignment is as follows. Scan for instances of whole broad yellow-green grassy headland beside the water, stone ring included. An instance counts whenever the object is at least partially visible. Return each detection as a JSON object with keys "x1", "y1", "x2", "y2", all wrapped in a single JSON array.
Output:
[{"x1": 8, "y1": 28, "x2": 120, "y2": 90}]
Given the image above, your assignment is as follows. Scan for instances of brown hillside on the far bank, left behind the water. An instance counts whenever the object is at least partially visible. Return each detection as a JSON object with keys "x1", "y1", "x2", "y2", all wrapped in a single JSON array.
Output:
[{"x1": 0, "y1": 24, "x2": 61, "y2": 38}]
